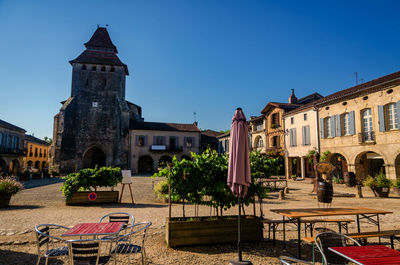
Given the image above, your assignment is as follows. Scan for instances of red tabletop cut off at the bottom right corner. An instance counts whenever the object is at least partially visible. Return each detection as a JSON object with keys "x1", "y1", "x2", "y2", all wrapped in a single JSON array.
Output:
[{"x1": 328, "y1": 245, "x2": 400, "y2": 265}]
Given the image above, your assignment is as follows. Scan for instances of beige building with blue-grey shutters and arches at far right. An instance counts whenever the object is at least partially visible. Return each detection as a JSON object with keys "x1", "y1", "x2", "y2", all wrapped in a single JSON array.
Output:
[{"x1": 316, "y1": 72, "x2": 400, "y2": 181}]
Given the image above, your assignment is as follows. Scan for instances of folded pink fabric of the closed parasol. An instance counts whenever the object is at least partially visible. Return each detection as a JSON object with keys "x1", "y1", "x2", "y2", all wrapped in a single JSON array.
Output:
[{"x1": 228, "y1": 108, "x2": 251, "y2": 198}]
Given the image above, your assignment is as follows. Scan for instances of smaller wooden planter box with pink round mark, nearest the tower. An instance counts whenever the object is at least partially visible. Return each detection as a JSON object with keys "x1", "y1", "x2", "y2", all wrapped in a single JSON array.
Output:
[{"x1": 65, "y1": 191, "x2": 118, "y2": 205}]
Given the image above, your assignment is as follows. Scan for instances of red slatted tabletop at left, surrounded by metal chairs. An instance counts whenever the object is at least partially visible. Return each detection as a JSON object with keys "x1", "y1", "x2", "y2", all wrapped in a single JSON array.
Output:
[{"x1": 61, "y1": 222, "x2": 125, "y2": 236}]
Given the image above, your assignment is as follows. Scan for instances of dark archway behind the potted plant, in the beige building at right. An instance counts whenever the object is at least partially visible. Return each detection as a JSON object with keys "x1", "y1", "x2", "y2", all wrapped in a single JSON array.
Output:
[{"x1": 355, "y1": 151, "x2": 386, "y2": 181}]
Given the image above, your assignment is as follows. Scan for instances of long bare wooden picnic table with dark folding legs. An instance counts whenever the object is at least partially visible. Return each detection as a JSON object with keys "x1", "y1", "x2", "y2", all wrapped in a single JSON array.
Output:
[{"x1": 271, "y1": 207, "x2": 393, "y2": 258}]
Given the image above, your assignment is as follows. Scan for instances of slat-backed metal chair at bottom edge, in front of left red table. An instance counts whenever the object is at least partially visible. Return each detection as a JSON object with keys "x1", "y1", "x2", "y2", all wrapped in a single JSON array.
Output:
[{"x1": 67, "y1": 239, "x2": 111, "y2": 265}]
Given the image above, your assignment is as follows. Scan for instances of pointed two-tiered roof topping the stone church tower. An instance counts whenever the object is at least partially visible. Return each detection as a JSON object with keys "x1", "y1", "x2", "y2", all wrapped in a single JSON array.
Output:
[{"x1": 69, "y1": 27, "x2": 129, "y2": 75}]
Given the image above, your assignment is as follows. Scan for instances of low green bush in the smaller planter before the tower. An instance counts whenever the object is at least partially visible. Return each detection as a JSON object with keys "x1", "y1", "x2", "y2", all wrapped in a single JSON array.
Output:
[{"x1": 61, "y1": 167, "x2": 122, "y2": 198}]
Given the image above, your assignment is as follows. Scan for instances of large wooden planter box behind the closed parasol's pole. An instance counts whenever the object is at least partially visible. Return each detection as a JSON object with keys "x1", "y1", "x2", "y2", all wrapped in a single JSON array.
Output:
[{"x1": 165, "y1": 216, "x2": 263, "y2": 247}]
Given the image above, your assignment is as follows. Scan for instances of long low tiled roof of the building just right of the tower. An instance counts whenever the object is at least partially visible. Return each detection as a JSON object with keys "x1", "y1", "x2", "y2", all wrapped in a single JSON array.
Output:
[{"x1": 130, "y1": 120, "x2": 200, "y2": 132}]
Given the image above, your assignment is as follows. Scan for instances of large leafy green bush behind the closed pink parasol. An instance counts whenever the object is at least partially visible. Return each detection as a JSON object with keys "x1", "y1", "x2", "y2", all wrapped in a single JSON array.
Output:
[{"x1": 153, "y1": 149, "x2": 279, "y2": 216}]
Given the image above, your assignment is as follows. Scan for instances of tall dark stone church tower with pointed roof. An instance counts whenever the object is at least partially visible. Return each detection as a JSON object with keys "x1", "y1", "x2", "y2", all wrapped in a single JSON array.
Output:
[{"x1": 52, "y1": 27, "x2": 143, "y2": 173}]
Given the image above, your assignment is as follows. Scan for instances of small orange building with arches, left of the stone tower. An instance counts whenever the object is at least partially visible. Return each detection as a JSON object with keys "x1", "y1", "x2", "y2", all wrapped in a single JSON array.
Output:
[{"x1": 24, "y1": 134, "x2": 50, "y2": 172}]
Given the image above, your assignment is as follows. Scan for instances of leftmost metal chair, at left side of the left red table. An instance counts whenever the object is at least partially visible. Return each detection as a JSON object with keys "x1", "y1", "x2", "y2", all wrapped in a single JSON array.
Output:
[{"x1": 35, "y1": 224, "x2": 69, "y2": 265}]
